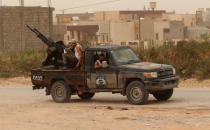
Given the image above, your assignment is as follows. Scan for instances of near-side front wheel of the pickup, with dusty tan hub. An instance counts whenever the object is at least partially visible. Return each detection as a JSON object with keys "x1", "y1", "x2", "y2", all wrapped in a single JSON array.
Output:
[{"x1": 126, "y1": 81, "x2": 149, "y2": 105}]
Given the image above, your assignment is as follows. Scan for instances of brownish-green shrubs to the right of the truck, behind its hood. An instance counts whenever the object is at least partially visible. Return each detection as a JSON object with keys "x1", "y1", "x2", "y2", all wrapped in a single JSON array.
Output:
[{"x1": 139, "y1": 41, "x2": 210, "y2": 80}]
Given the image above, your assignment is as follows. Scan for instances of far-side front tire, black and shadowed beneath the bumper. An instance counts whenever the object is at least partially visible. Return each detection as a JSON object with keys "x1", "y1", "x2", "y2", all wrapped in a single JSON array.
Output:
[{"x1": 153, "y1": 89, "x2": 174, "y2": 101}]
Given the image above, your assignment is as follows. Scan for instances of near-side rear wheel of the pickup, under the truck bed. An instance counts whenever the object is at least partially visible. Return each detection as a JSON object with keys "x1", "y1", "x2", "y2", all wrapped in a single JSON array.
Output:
[{"x1": 51, "y1": 81, "x2": 71, "y2": 103}]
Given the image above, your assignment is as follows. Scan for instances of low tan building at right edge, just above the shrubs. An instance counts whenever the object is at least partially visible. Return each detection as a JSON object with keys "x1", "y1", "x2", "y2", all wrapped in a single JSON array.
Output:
[{"x1": 186, "y1": 27, "x2": 210, "y2": 40}]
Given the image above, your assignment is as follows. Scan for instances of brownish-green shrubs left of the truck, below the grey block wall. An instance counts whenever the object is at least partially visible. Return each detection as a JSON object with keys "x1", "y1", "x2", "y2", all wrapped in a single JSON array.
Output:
[{"x1": 0, "y1": 51, "x2": 45, "y2": 78}]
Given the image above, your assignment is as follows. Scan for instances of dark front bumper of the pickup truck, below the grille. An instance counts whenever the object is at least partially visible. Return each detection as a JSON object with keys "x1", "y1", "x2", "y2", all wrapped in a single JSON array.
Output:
[{"x1": 144, "y1": 76, "x2": 179, "y2": 91}]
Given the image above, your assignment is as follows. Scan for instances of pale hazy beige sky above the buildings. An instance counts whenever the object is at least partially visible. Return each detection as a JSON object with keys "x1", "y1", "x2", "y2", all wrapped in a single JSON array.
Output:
[{"x1": 2, "y1": 0, "x2": 210, "y2": 13}]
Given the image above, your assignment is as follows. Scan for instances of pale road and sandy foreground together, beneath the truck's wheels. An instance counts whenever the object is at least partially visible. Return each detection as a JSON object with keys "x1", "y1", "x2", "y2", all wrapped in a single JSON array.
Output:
[{"x1": 0, "y1": 86, "x2": 210, "y2": 130}]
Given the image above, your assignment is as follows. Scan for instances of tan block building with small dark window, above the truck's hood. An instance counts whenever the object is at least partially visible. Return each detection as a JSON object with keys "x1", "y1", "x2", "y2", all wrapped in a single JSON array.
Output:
[{"x1": 140, "y1": 19, "x2": 184, "y2": 46}]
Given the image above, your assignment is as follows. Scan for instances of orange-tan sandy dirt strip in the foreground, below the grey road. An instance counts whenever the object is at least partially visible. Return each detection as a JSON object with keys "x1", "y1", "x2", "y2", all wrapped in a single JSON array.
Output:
[{"x1": 0, "y1": 104, "x2": 210, "y2": 130}]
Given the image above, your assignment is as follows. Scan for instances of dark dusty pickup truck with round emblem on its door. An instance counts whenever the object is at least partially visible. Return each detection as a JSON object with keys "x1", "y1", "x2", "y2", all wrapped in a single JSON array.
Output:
[{"x1": 31, "y1": 46, "x2": 179, "y2": 105}]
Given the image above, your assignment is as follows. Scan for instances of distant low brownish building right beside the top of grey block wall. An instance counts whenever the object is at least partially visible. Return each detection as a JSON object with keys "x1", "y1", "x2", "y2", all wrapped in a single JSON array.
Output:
[{"x1": 56, "y1": 13, "x2": 96, "y2": 25}]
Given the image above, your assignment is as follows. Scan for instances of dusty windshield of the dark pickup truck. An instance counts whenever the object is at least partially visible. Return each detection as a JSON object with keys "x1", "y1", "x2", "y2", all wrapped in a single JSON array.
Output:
[{"x1": 111, "y1": 48, "x2": 140, "y2": 65}]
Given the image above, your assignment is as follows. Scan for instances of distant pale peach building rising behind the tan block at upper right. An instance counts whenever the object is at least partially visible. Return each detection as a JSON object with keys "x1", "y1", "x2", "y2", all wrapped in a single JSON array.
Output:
[{"x1": 162, "y1": 12, "x2": 196, "y2": 27}]
